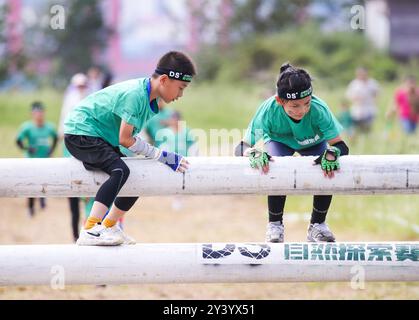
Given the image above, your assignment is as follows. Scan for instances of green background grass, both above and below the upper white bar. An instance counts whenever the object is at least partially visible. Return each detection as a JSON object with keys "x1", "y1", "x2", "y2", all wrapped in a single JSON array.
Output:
[{"x1": 0, "y1": 84, "x2": 419, "y2": 240}]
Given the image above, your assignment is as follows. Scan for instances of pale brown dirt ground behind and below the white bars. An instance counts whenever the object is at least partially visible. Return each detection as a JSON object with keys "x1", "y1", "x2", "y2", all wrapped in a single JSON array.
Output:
[{"x1": 0, "y1": 196, "x2": 419, "y2": 300}]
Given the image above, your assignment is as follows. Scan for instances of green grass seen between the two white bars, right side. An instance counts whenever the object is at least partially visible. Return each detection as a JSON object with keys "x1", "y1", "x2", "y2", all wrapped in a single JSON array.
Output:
[{"x1": 282, "y1": 195, "x2": 419, "y2": 241}]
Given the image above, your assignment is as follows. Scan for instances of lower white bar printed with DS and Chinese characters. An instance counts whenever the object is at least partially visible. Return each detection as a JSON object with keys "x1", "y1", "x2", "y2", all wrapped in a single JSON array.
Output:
[{"x1": 0, "y1": 242, "x2": 419, "y2": 286}]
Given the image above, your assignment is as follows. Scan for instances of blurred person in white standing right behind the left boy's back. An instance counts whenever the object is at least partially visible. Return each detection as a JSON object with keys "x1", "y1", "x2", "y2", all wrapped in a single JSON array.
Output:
[{"x1": 58, "y1": 73, "x2": 88, "y2": 241}]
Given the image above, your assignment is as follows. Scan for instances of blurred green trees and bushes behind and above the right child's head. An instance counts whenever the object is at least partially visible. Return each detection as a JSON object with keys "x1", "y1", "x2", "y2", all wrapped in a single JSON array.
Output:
[{"x1": 196, "y1": 0, "x2": 401, "y2": 86}]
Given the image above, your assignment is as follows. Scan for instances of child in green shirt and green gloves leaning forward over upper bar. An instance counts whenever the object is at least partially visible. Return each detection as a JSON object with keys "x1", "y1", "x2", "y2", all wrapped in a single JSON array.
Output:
[{"x1": 235, "y1": 63, "x2": 349, "y2": 242}]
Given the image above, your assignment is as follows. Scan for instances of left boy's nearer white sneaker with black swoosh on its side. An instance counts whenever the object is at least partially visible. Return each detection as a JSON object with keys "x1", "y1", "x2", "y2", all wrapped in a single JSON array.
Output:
[{"x1": 76, "y1": 224, "x2": 124, "y2": 246}]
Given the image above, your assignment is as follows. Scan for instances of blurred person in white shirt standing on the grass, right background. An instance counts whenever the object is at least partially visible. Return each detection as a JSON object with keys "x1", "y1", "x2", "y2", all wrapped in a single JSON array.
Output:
[{"x1": 346, "y1": 67, "x2": 379, "y2": 133}]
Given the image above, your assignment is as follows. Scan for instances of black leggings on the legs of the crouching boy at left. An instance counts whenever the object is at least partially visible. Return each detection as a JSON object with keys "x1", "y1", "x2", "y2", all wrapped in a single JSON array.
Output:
[{"x1": 95, "y1": 159, "x2": 138, "y2": 211}]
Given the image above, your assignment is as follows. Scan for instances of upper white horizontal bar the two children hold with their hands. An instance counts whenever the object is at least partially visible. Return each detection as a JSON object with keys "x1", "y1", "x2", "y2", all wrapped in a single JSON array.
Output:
[{"x1": 0, "y1": 155, "x2": 419, "y2": 197}]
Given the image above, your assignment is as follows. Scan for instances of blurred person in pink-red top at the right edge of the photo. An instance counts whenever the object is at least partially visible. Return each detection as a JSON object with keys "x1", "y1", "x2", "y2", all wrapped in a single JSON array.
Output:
[{"x1": 386, "y1": 76, "x2": 419, "y2": 135}]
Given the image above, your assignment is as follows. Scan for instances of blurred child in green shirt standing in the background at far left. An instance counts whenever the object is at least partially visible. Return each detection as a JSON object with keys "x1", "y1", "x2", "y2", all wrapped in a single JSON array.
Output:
[{"x1": 16, "y1": 101, "x2": 58, "y2": 217}]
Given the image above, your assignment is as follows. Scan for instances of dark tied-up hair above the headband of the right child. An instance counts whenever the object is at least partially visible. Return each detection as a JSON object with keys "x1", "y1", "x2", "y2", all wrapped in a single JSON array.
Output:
[{"x1": 276, "y1": 63, "x2": 312, "y2": 99}]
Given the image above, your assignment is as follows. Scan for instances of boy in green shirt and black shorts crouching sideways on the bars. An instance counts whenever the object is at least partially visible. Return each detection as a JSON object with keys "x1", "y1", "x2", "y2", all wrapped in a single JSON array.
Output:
[{"x1": 64, "y1": 51, "x2": 196, "y2": 246}]
